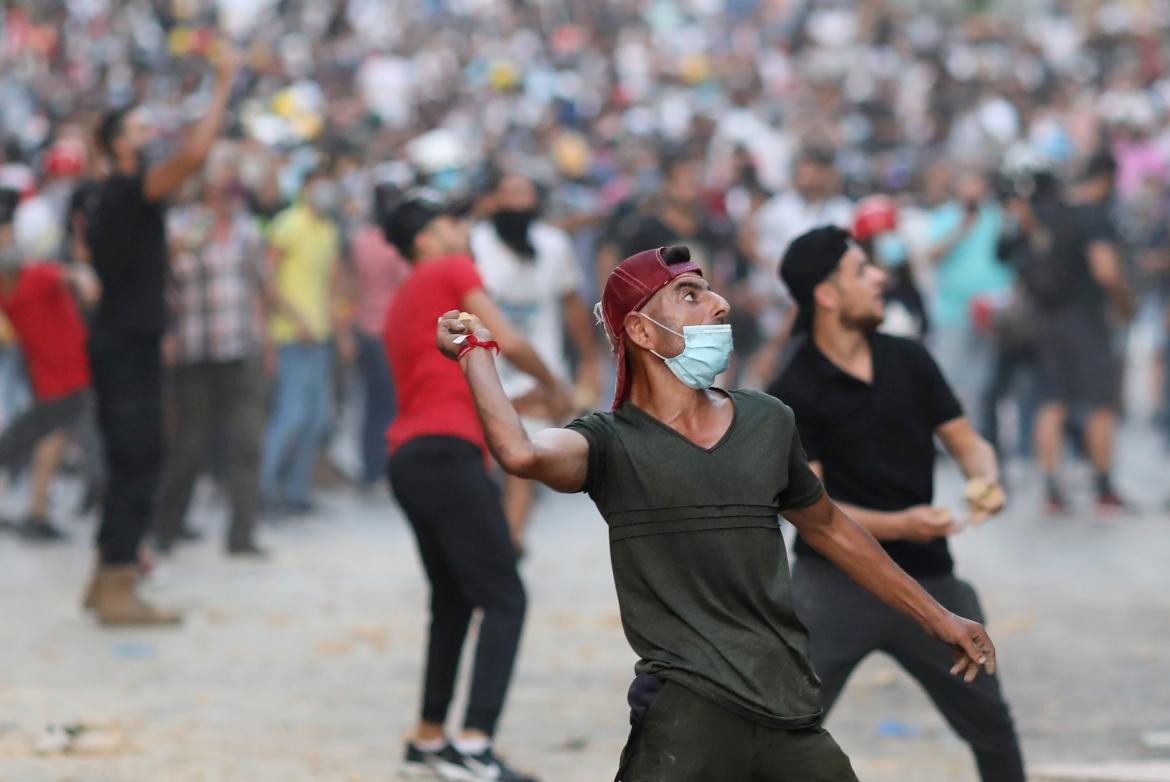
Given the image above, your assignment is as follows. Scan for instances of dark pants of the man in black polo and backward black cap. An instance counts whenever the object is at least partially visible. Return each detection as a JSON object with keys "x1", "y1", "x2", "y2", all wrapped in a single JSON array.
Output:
[{"x1": 792, "y1": 557, "x2": 1025, "y2": 782}]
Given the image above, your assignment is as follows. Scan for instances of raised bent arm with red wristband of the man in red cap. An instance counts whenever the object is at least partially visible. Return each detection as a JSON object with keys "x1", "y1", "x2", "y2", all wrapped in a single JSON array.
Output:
[{"x1": 436, "y1": 310, "x2": 589, "y2": 492}]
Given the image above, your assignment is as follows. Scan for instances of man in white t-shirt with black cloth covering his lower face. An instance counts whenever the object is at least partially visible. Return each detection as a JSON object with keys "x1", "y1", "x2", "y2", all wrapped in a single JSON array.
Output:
[{"x1": 472, "y1": 173, "x2": 601, "y2": 550}]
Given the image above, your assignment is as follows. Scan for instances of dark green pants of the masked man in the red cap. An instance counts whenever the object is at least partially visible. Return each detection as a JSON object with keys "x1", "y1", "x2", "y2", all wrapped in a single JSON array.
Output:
[{"x1": 617, "y1": 681, "x2": 858, "y2": 782}]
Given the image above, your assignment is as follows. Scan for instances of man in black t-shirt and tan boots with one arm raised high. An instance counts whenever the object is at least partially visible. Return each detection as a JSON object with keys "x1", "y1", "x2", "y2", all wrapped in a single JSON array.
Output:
[{"x1": 84, "y1": 50, "x2": 238, "y2": 625}]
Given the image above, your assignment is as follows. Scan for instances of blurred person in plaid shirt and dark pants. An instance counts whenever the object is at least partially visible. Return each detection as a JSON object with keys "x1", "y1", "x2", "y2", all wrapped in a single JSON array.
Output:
[{"x1": 153, "y1": 146, "x2": 267, "y2": 556}]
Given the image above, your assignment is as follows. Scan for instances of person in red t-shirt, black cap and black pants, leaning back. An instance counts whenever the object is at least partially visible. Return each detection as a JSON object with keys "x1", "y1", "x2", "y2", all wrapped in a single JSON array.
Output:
[{"x1": 383, "y1": 197, "x2": 571, "y2": 782}]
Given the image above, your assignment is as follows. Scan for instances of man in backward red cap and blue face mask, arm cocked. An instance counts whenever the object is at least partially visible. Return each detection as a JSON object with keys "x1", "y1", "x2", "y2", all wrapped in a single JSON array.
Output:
[{"x1": 438, "y1": 246, "x2": 995, "y2": 782}]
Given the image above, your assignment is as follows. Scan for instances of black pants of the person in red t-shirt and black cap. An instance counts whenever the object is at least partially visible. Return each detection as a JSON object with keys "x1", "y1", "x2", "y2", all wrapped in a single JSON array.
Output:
[{"x1": 390, "y1": 437, "x2": 527, "y2": 735}]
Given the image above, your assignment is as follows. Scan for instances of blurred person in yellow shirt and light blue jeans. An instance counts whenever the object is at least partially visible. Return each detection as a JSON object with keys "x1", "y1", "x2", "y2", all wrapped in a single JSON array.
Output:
[{"x1": 260, "y1": 171, "x2": 352, "y2": 513}]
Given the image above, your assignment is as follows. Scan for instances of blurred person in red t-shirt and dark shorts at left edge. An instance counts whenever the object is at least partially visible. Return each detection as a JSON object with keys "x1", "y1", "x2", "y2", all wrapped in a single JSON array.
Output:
[{"x1": 0, "y1": 191, "x2": 101, "y2": 541}]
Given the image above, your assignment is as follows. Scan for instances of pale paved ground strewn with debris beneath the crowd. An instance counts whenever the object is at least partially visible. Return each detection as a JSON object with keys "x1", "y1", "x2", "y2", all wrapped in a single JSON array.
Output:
[{"x1": 0, "y1": 423, "x2": 1170, "y2": 782}]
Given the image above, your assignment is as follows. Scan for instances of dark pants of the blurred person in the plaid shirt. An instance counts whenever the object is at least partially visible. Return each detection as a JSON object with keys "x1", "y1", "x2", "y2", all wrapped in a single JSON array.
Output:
[{"x1": 154, "y1": 361, "x2": 264, "y2": 547}]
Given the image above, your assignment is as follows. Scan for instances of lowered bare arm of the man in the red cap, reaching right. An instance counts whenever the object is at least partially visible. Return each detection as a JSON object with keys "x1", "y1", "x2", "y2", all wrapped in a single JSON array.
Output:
[{"x1": 784, "y1": 495, "x2": 996, "y2": 681}]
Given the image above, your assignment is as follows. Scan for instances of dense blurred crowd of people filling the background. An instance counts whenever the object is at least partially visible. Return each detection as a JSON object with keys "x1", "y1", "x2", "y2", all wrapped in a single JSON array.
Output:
[{"x1": 0, "y1": 0, "x2": 1170, "y2": 549}]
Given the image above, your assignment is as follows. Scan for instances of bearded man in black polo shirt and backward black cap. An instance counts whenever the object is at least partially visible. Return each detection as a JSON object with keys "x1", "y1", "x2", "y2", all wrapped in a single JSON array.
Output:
[{"x1": 769, "y1": 226, "x2": 1024, "y2": 782}]
